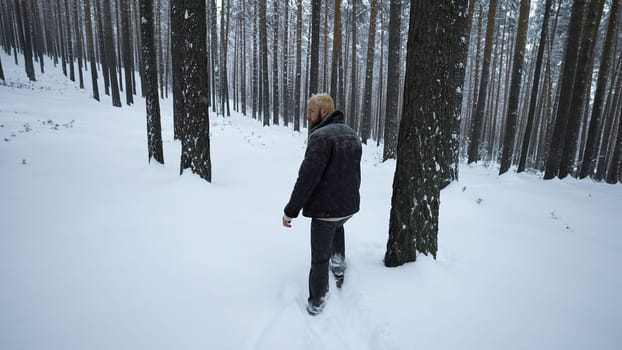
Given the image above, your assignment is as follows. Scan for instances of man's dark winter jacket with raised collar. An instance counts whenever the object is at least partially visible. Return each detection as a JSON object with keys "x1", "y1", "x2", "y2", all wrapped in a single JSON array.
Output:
[{"x1": 285, "y1": 111, "x2": 361, "y2": 218}]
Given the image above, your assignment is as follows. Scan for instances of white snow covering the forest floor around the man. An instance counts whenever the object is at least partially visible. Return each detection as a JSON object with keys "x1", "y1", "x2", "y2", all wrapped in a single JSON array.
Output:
[{"x1": 0, "y1": 53, "x2": 622, "y2": 350}]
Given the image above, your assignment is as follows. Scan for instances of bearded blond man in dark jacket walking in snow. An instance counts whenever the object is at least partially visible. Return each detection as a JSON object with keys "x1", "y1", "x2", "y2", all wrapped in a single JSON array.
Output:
[{"x1": 283, "y1": 94, "x2": 361, "y2": 316}]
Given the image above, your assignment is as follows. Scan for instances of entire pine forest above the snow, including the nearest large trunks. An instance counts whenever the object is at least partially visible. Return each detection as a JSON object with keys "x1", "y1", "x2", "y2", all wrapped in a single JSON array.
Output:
[{"x1": 0, "y1": 0, "x2": 622, "y2": 266}]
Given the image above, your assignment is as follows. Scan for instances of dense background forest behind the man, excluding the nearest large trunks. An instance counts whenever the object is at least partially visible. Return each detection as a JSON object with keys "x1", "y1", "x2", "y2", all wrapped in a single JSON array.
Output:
[{"x1": 0, "y1": 0, "x2": 622, "y2": 183}]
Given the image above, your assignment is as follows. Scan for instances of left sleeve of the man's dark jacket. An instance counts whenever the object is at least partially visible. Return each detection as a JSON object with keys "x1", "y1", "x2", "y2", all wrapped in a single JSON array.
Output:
[{"x1": 284, "y1": 134, "x2": 331, "y2": 218}]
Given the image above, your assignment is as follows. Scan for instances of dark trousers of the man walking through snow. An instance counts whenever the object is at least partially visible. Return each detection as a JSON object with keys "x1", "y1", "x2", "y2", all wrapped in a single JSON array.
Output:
[{"x1": 309, "y1": 219, "x2": 348, "y2": 305}]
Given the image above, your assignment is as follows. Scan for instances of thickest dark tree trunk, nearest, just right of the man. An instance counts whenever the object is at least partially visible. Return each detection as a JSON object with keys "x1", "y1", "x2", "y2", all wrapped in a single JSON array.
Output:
[{"x1": 384, "y1": 0, "x2": 467, "y2": 266}]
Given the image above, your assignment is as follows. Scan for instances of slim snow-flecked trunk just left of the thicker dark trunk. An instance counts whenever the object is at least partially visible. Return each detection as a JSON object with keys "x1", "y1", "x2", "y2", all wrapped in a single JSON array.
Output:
[{"x1": 139, "y1": 0, "x2": 164, "y2": 164}]
